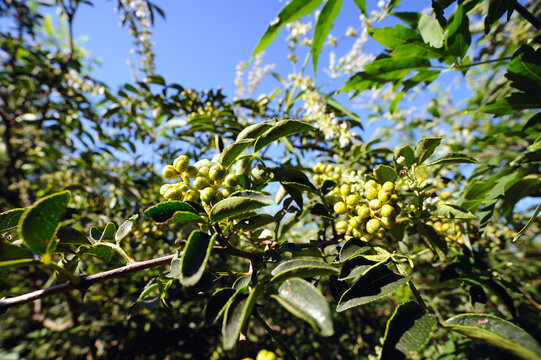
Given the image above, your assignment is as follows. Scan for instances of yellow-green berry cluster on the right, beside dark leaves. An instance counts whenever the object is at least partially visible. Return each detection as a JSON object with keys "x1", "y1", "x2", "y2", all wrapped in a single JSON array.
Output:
[{"x1": 313, "y1": 163, "x2": 401, "y2": 241}]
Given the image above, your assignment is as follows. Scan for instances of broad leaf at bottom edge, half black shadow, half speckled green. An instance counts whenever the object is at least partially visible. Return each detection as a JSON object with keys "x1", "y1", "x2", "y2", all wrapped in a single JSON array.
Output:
[{"x1": 381, "y1": 301, "x2": 437, "y2": 360}]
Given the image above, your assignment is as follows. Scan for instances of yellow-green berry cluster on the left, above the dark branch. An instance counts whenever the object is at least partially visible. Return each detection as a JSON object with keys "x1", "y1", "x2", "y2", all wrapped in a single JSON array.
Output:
[{"x1": 160, "y1": 155, "x2": 239, "y2": 205}]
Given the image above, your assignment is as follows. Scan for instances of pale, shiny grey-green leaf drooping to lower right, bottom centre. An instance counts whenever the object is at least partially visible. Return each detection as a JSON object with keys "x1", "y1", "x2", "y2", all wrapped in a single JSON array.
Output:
[{"x1": 272, "y1": 278, "x2": 334, "y2": 336}]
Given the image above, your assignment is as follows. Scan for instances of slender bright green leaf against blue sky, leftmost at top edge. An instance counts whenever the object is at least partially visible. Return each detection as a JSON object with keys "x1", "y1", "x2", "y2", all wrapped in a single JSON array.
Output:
[{"x1": 252, "y1": 0, "x2": 322, "y2": 64}]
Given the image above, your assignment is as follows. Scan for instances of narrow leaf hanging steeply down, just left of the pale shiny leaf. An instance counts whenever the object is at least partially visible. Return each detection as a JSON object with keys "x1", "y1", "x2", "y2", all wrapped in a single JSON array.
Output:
[{"x1": 222, "y1": 282, "x2": 264, "y2": 350}]
